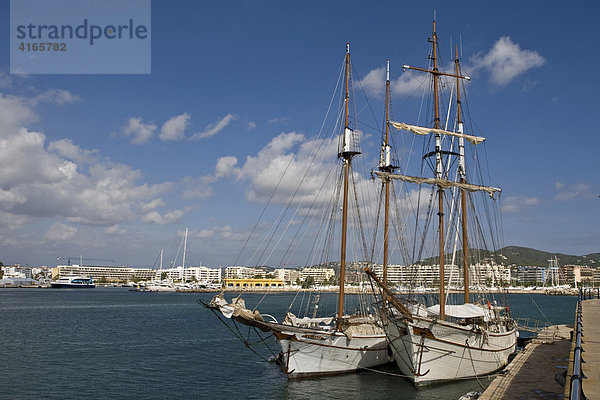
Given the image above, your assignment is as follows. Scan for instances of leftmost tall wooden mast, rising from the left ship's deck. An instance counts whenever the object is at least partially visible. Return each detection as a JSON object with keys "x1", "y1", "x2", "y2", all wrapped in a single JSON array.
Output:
[{"x1": 336, "y1": 42, "x2": 360, "y2": 331}]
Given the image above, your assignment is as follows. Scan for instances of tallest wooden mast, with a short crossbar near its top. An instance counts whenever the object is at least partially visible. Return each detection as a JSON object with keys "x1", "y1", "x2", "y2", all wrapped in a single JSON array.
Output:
[{"x1": 402, "y1": 20, "x2": 471, "y2": 320}]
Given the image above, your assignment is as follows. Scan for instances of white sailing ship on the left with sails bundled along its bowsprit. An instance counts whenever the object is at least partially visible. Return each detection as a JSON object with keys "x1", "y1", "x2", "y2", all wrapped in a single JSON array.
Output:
[{"x1": 206, "y1": 44, "x2": 391, "y2": 378}]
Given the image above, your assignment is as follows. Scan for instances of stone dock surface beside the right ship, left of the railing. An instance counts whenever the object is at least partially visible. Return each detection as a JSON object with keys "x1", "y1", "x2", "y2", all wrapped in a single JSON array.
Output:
[{"x1": 479, "y1": 324, "x2": 572, "y2": 400}]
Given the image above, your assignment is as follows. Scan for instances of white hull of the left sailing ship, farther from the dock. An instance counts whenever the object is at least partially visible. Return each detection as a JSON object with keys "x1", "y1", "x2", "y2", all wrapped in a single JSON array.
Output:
[{"x1": 275, "y1": 325, "x2": 392, "y2": 379}]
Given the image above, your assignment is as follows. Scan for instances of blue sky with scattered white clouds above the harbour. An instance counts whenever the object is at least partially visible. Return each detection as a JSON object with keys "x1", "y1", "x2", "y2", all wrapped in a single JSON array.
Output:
[{"x1": 0, "y1": 0, "x2": 600, "y2": 266}]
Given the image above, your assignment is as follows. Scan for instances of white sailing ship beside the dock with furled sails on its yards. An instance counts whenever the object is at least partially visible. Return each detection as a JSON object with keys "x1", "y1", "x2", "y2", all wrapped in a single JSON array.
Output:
[{"x1": 365, "y1": 21, "x2": 518, "y2": 386}]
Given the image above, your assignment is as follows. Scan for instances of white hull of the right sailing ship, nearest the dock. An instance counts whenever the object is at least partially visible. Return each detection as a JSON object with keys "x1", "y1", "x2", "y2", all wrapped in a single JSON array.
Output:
[{"x1": 386, "y1": 318, "x2": 517, "y2": 386}]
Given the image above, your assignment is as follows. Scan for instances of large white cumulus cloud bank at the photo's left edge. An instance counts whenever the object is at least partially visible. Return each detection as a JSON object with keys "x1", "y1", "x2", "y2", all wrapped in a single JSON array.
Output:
[{"x1": 0, "y1": 94, "x2": 172, "y2": 226}]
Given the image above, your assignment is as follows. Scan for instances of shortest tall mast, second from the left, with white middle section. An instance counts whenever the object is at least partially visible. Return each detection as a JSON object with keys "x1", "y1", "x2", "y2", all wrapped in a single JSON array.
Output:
[{"x1": 379, "y1": 60, "x2": 394, "y2": 284}]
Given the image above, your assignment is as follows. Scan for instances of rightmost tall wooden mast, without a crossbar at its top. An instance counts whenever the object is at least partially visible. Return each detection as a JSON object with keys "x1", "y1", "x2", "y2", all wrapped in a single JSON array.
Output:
[{"x1": 454, "y1": 46, "x2": 470, "y2": 304}]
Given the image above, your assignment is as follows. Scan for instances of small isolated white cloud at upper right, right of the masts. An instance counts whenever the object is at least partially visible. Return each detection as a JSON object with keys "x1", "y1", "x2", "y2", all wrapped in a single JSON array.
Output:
[{"x1": 471, "y1": 36, "x2": 546, "y2": 86}]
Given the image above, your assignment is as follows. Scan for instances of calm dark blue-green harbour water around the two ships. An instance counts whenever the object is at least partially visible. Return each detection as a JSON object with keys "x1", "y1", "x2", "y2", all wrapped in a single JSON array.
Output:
[{"x1": 0, "y1": 288, "x2": 576, "y2": 399}]
